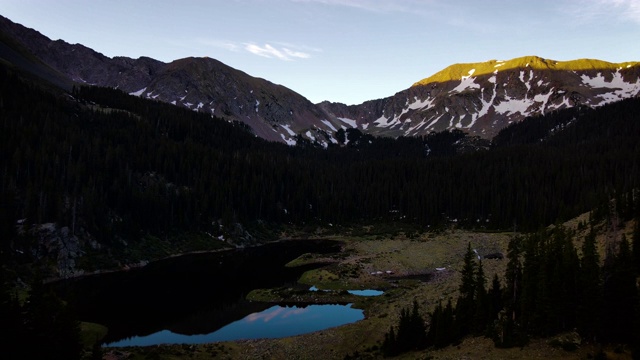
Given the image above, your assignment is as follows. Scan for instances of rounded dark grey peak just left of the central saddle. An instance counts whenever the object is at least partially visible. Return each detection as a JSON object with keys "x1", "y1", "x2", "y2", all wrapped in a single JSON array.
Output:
[{"x1": 131, "y1": 58, "x2": 340, "y2": 143}]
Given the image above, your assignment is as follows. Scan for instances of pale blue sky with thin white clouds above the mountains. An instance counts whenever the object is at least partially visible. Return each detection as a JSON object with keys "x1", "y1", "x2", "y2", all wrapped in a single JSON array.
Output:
[{"x1": 0, "y1": 0, "x2": 640, "y2": 104}]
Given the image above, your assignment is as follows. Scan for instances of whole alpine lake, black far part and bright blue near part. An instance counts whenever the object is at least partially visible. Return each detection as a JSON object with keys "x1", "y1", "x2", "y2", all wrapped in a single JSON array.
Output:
[{"x1": 52, "y1": 240, "x2": 382, "y2": 347}]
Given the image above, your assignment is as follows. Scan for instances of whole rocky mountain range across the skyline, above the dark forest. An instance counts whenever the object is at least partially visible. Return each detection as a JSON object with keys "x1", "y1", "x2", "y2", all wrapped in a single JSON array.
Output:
[{"x1": 0, "y1": 16, "x2": 640, "y2": 146}]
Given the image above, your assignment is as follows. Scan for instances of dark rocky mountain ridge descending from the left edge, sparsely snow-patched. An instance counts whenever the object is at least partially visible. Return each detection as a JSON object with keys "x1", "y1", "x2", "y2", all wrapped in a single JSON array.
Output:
[{"x1": 0, "y1": 16, "x2": 344, "y2": 145}]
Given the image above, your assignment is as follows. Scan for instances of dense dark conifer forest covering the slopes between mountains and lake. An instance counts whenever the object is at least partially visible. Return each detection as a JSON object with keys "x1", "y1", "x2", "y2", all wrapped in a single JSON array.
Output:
[{"x1": 0, "y1": 62, "x2": 640, "y2": 253}]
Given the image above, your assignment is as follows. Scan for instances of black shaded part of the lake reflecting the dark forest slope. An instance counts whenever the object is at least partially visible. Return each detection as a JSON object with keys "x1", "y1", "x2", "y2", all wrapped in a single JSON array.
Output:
[{"x1": 49, "y1": 240, "x2": 340, "y2": 344}]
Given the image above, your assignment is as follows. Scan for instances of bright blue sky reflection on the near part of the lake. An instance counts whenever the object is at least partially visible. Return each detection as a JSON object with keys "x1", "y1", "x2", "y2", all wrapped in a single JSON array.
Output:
[{"x1": 106, "y1": 304, "x2": 364, "y2": 346}]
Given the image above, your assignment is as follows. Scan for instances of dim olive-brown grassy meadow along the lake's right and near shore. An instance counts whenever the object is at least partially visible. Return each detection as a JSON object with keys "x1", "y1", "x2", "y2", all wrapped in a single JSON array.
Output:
[{"x1": 97, "y1": 214, "x2": 634, "y2": 359}]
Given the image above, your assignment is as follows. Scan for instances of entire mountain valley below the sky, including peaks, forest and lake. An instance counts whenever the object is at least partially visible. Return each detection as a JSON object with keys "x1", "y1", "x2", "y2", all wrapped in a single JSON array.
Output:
[{"x1": 0, "y1": 16, "x2": 640, "y2": 360}]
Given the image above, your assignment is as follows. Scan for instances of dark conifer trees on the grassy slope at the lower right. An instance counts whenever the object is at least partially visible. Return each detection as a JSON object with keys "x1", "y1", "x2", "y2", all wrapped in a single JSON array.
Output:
[{"x1": 382, "y1": 219, "x2": 640, "y2": 356}]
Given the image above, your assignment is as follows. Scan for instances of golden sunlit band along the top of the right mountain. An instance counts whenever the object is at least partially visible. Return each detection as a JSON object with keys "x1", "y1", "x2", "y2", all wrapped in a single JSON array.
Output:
[{"x1": 413, "y1": 56, "x2": 640, "y2": 86}]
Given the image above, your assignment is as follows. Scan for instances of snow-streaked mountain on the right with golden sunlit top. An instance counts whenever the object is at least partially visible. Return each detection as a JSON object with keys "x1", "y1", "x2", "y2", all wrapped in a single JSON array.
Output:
[{"x1": 319, "y1": 56, "x2": 640, "y2": 138}]
